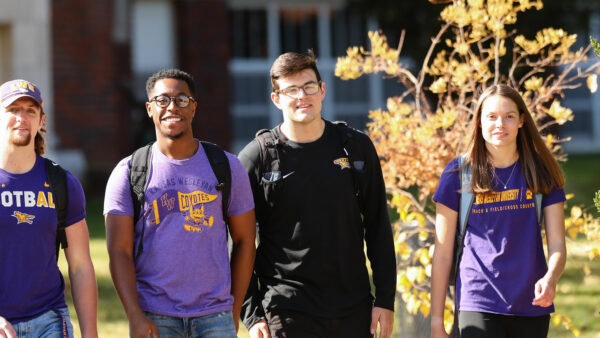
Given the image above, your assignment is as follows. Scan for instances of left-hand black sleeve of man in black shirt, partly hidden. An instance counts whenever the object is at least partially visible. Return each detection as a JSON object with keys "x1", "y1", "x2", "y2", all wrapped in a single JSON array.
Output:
[{"x1": 238, "y1": 140, "x2": 265, "y2": 329}]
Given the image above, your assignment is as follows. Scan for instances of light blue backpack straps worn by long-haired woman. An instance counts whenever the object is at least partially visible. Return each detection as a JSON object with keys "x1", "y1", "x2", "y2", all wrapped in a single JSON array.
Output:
[{"x1": 449, "y1": 156, "x2": 543, "y2": 286}]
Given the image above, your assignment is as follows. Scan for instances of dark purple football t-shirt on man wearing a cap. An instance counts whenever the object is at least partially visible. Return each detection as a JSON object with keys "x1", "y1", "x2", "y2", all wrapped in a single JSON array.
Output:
[{"x1": 0, "y1": 156, "x2": 85, "y2": 324}]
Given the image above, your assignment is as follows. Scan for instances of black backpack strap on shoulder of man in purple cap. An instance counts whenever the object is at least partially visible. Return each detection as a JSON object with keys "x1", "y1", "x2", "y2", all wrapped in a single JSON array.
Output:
[{"x1": 44, "y1": 158, "x2": 69, "y2": 261}]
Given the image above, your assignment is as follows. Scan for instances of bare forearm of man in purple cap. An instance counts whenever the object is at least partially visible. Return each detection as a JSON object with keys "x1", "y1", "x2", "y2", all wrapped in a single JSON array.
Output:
[{"x1": 69, "y1": 261, "x2": 98, "y2": 338}]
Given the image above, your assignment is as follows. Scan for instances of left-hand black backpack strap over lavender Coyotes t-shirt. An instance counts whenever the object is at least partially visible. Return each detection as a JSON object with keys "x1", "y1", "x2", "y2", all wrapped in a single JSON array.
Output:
[{"x1": 129, "y1": 142, "x2": 154, "y2": 260}]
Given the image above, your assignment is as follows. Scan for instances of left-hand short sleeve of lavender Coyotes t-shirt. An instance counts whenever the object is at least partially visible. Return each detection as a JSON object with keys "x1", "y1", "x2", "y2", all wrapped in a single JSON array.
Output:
[{"x1": 103, "y1": 156, "x2": 133, "y2": 216}]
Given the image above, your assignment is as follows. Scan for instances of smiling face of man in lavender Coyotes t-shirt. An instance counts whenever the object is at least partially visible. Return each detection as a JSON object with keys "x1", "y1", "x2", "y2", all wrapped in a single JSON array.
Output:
[{"x1": 146, "y1": 78, "x2": 197, "y2": 140}]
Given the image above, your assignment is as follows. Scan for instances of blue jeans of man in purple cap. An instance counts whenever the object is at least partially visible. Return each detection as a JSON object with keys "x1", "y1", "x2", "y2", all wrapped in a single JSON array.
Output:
[{"x1": 13, "y1": 307, "x2": 73, "y2": 338}]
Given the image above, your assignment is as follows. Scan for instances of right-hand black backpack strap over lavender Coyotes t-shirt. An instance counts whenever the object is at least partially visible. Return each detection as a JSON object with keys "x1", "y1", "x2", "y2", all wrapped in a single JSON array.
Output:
[{"x1": 200, "y1": 141, "x2": 231, "y2": 224}]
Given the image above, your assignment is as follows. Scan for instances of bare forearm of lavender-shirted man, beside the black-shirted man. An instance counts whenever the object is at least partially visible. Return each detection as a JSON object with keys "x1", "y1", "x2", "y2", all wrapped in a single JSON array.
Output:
[{"x1": 231, "y1": 240, "x2": 256, "y2": 323}]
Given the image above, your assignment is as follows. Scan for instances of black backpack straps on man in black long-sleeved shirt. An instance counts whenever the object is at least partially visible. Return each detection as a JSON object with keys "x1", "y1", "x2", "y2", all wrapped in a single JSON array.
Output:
[{"x1": 255, "y1": 121, "x2": 367, "y2": 209}]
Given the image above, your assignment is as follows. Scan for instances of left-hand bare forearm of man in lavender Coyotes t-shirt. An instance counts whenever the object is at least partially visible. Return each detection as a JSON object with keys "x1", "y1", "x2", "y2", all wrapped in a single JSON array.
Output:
[{"x1": 109, "y1": 250, "x2": 142, "y2": 322}]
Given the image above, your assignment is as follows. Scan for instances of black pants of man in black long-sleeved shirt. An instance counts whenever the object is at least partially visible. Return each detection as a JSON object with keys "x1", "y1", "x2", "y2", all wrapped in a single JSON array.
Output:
[{"x1": 266, "y1": 302, "x2": 373, "y2": 338}]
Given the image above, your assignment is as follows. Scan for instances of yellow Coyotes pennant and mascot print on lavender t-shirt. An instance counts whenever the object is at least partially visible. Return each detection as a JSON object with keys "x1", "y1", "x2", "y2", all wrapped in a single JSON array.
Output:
[{"x1": 177, "y1": 190, "x2": 218, "y2": 232}]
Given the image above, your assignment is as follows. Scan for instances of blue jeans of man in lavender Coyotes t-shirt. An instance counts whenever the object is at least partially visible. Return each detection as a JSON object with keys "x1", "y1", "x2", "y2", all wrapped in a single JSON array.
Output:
[{"x1": 144, "y1": 311, "x2": 237, "y2": 338}]
